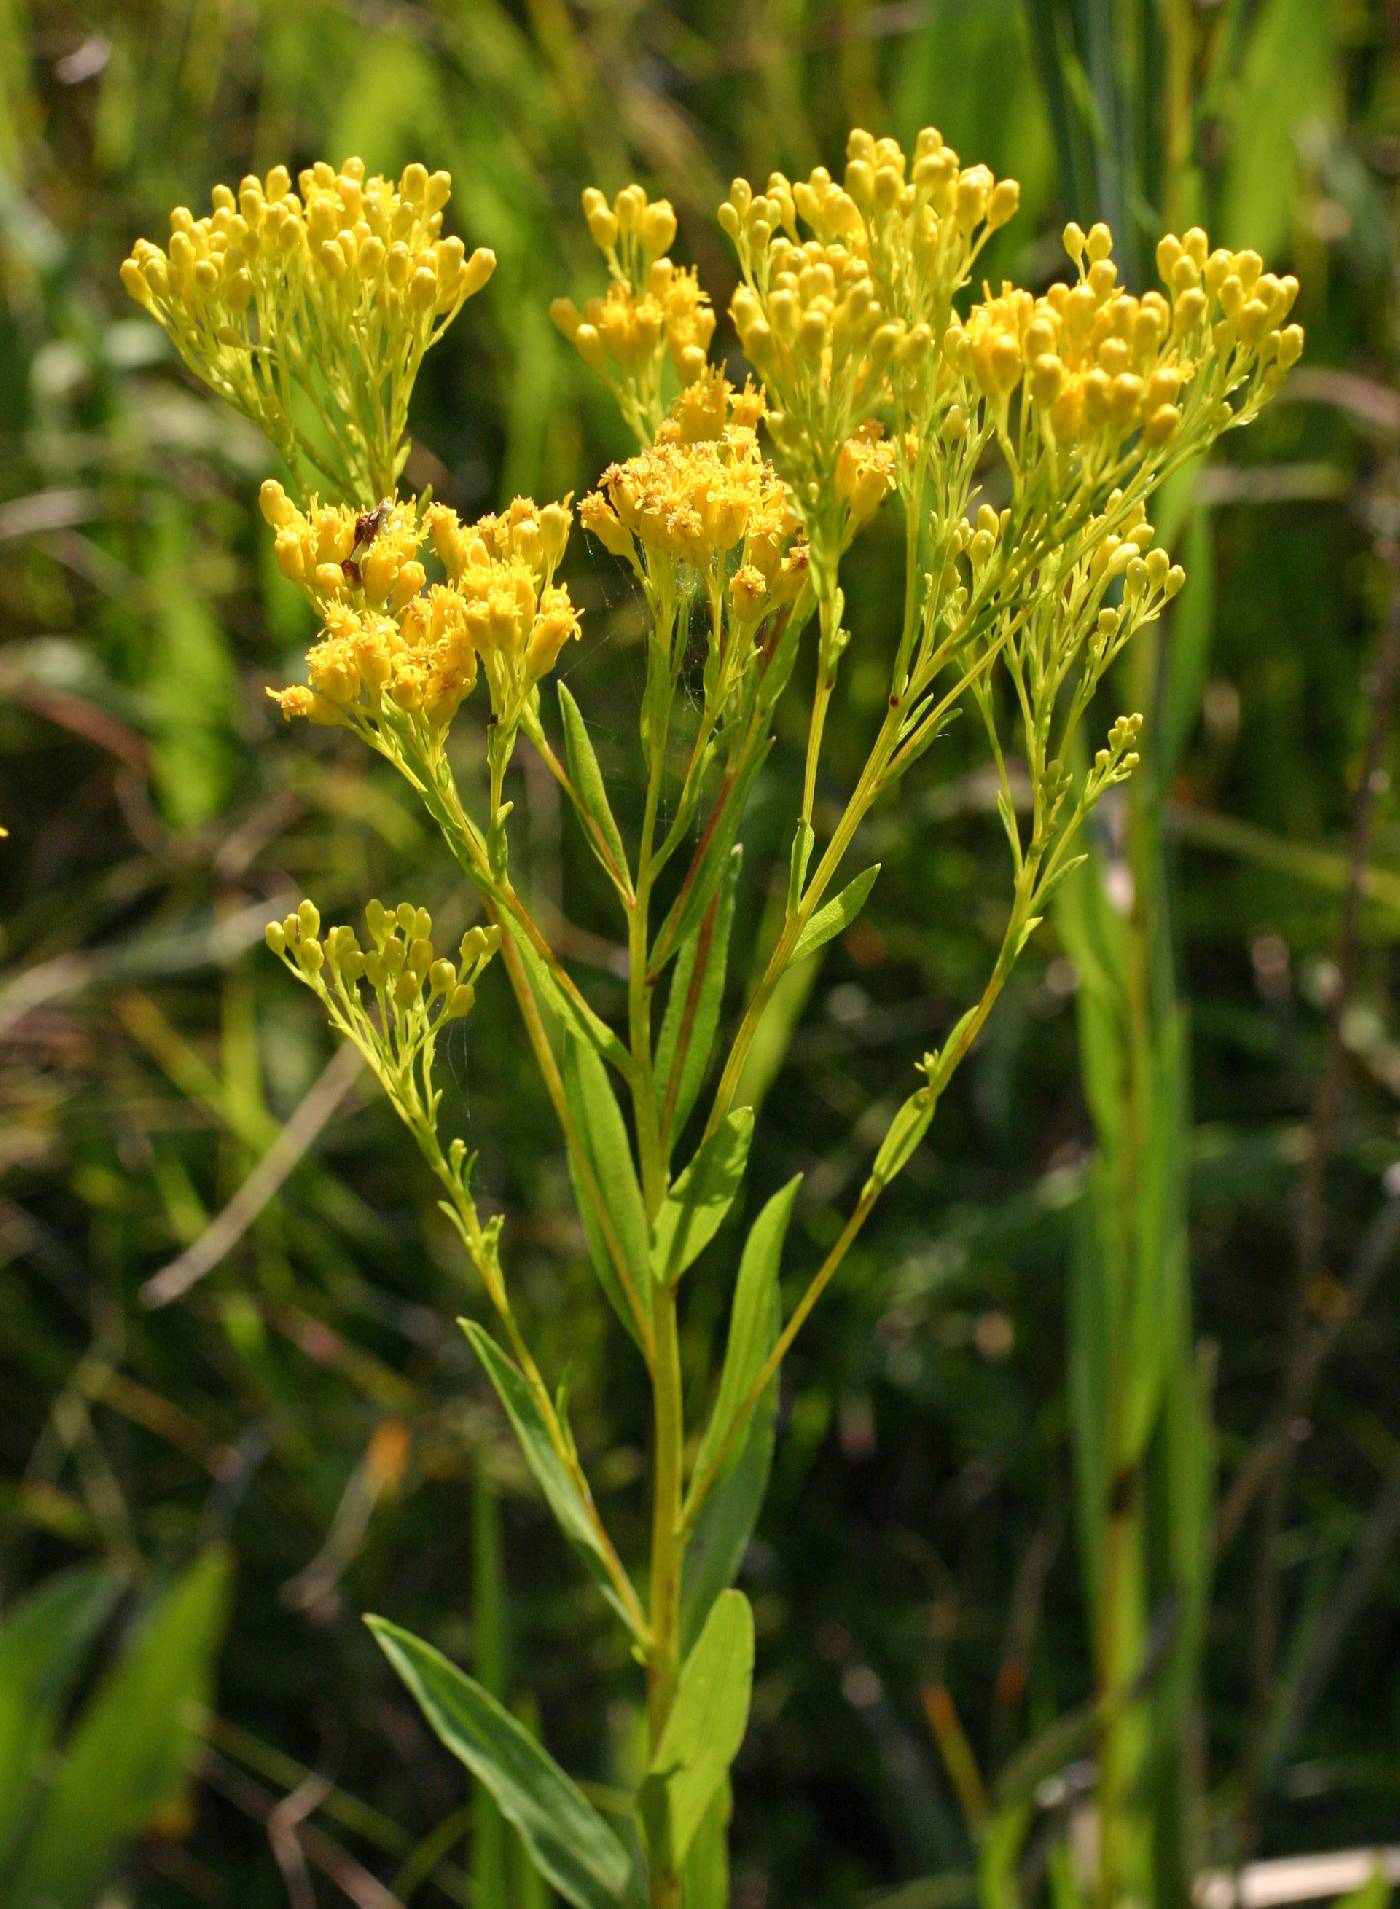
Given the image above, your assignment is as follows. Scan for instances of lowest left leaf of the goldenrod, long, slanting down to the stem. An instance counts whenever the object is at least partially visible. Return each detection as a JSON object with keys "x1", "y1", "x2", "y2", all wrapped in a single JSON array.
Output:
[{"x1": 365, "y1": 1617, "x2": 630, "y2": 1909}]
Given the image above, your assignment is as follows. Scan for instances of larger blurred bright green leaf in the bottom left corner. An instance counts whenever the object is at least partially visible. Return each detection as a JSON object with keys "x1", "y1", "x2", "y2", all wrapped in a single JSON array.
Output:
[{"x1": 6, "y1": 1550, "x2": 229, "y2": 1909}]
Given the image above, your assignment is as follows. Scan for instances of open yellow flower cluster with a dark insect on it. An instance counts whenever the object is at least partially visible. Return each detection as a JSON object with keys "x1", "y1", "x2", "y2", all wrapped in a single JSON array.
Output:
[{"x1": 264, "y1": 487, "x2": 579, "y2": 731}]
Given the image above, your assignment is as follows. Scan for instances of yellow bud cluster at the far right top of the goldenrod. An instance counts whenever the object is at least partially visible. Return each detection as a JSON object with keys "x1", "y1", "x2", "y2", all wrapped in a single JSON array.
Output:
[{"x1": 947, "y1": 225, "x2": 1303, "y2": 471}]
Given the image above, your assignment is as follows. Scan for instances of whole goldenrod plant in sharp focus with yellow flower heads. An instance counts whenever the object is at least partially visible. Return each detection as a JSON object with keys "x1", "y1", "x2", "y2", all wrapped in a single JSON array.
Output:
[{"x1": 124, "y1": 128, "x2": 1303, "y2": 1909}]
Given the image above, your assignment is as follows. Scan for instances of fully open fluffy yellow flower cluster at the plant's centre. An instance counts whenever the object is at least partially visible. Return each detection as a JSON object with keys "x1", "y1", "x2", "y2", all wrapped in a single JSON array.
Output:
[{"x1": 579, "y1": 410, "x2": 806, "y2": 619}]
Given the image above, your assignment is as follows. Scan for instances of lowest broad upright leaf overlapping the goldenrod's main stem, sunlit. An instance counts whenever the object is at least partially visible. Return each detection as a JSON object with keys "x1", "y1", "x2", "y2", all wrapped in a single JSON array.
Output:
[{"x1": 651, "y1": 1590, "x2": 754, "y2": 1863}]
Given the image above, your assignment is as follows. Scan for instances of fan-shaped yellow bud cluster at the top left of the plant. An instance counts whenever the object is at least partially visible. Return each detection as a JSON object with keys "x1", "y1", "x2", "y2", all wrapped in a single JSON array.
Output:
[{"x1": 122, "y1": 158, "x2": 495, "y2": 504}]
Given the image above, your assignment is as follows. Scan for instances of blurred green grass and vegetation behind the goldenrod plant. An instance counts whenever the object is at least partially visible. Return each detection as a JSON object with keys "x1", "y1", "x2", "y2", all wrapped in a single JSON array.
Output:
[{"x1": 0, "y1": 0, "x2": 1400, "y2": 1909}]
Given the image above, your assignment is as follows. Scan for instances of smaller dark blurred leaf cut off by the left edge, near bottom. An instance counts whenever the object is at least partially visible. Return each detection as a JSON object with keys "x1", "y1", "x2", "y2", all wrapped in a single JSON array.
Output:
[{"x1": 0, "y1": 1565, "x2": 118, "y2": 1865}]
